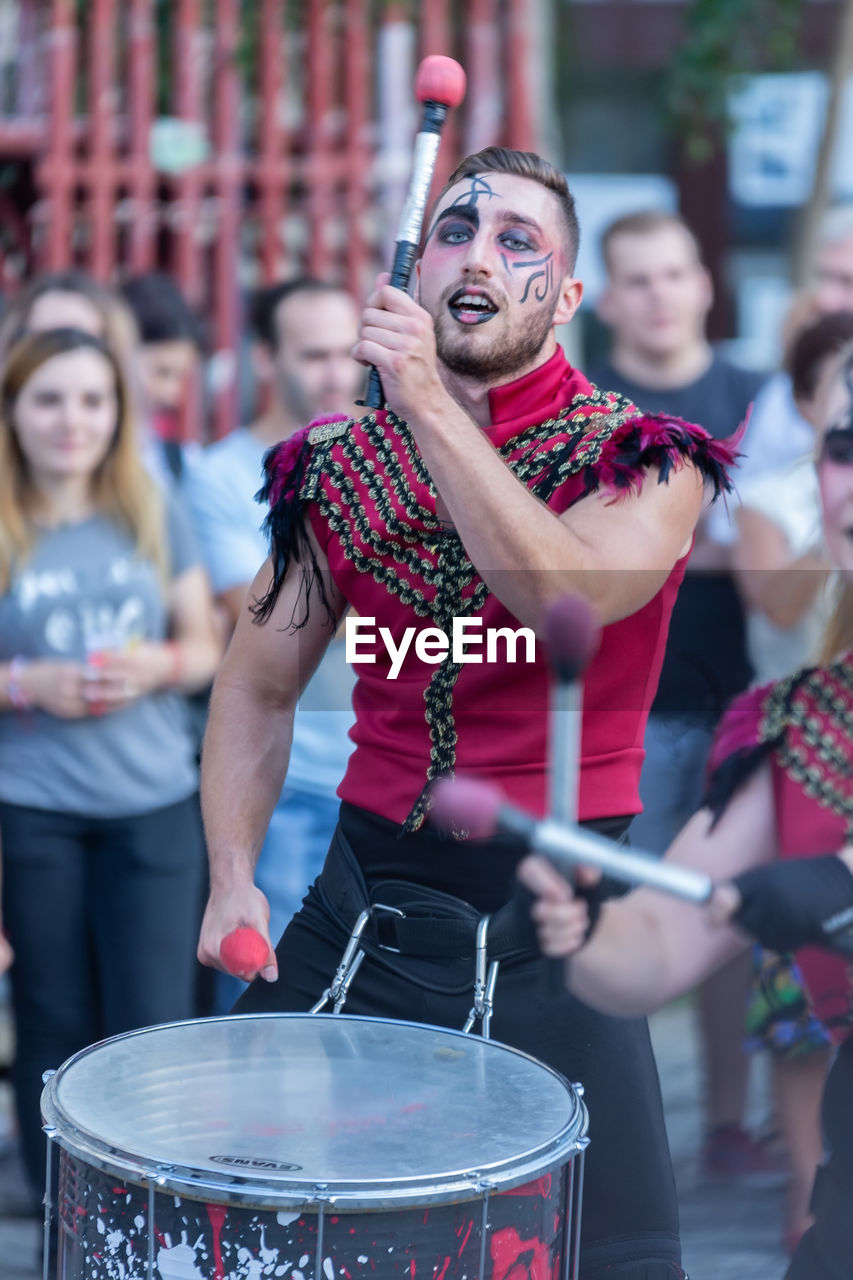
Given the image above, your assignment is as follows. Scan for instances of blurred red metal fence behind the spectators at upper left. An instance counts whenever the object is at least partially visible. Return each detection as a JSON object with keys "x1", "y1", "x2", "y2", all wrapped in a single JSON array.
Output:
[{"x1": 0, "y1": 0, "x2": 535, "y2": 434}]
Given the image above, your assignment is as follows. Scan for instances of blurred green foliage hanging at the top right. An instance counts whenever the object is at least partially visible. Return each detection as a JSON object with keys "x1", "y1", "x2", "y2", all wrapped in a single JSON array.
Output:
[{"x1": 663, "y1": 0, "x2": 806, "y2": 164}]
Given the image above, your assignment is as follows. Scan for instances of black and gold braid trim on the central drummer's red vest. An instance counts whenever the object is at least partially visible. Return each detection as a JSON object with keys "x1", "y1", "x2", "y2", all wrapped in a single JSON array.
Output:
[{"x1": 300, "y1": 390, "x2": 653, "y2": 831}]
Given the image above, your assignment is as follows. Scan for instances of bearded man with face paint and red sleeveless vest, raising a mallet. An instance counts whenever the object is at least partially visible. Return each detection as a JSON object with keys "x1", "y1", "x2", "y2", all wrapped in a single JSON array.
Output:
[{"x1": 199, "y1": 147, "x2": 730, "y2": 1280}]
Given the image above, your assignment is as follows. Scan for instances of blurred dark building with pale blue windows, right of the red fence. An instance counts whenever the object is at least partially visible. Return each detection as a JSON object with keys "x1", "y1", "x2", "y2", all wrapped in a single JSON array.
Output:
[{"x1": 551, "y1": 0, "x2": 853, "y2": 367}]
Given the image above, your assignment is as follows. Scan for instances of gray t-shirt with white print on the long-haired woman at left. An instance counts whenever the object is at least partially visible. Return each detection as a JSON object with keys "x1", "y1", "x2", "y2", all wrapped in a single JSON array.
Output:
[{"x1": 0, "y1": 499, "x2": 199, "y2": 818}]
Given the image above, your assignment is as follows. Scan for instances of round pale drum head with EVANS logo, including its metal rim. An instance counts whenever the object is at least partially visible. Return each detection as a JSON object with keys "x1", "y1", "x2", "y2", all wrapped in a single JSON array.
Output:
[{"x1": 42, "y1": 1014, "x2": 587, "y2": 1208}]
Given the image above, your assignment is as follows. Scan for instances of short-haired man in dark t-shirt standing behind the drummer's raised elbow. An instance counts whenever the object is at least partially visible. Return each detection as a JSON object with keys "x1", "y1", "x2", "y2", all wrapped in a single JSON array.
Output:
[{"x1": 589, "y1": 211, "x2": 779, "y2": 1179}]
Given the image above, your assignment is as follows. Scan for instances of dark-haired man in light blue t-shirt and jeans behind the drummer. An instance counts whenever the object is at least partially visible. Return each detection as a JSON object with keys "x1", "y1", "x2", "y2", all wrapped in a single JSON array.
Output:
[{"x1": 184, "y1": 278, "x2": 364, "y2": 1010}]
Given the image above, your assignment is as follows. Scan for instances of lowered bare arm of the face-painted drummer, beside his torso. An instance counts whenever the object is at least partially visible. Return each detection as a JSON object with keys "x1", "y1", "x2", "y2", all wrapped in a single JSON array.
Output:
[{"x1": 199, "y1": 535, "x2": 346, "y2": 978}]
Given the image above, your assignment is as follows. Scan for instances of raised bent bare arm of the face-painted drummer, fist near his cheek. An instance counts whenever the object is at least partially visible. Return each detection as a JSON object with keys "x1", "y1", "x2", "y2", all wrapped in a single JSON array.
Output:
[{"x1": 355, "y1": 285, "x2": 703, "y2": 627}]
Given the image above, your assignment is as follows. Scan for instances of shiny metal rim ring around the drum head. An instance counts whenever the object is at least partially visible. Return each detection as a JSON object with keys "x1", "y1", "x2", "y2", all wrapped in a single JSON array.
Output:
[{"x1": 41, "y1": 1011, "x2": 589, "y2": 1212}]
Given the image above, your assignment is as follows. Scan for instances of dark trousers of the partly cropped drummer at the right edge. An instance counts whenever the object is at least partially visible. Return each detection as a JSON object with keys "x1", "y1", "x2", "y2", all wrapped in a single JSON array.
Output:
[{"x1": 785, "y1": 1039, "x2": 853, "y2": 1280}]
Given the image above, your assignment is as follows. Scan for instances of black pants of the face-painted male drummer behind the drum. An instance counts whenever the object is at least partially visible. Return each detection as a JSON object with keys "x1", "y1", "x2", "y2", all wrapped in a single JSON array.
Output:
[{"x1": 234, "y1": 828, "x2": 683, "y2": 1280}]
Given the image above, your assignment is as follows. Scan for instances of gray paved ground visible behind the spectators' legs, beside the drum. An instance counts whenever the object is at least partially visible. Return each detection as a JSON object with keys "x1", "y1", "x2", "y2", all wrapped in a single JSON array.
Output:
[{"x1": 0, "y1": 1001, "x2": 785, "y2": 1280}]
